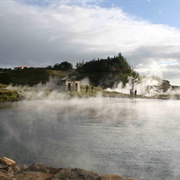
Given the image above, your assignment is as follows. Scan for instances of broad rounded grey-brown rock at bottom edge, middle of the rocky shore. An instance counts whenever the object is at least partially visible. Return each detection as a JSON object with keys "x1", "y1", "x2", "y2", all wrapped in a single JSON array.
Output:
[{"x1": 55, "y1": 168, "x2": 99, "y2": 180}]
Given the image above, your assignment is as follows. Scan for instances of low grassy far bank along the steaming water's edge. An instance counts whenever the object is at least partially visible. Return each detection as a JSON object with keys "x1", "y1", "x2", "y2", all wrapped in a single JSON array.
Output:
[{"x1": 0, "y1": 88, "x2": 180, "y2": 103}]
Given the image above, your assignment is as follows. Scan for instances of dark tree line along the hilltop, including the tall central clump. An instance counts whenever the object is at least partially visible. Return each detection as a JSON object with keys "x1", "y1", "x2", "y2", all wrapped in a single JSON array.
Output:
[{"x1": 0, "y1": 53, "x2": 139, "y2": 88}]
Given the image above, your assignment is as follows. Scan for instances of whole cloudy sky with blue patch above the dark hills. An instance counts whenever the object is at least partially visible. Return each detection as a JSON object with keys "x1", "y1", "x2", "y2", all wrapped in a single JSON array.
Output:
[{"x1": 0, "y1": 0, "x2": 180, "y2": 85}]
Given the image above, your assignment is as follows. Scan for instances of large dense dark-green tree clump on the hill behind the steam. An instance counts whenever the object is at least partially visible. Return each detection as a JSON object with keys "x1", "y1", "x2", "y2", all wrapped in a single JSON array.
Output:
[{"x1": 76, "y1": 53, "x2": 138, "y2": 88}]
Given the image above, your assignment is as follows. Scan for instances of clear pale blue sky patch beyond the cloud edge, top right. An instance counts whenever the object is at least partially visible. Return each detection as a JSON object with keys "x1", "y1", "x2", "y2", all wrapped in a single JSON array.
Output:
[{"x1": 114, "y1": 0, "x2": 180, "y2": 28}]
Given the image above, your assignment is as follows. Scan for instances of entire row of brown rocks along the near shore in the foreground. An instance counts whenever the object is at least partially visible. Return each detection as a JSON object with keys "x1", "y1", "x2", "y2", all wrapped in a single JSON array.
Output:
[{"x1": 0, "y1": 157, "x2": 137, "y2": 180}]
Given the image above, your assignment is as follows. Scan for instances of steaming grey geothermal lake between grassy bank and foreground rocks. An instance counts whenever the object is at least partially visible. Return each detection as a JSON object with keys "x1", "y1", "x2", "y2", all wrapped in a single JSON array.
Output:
[{"x1": 0, "y1": 97, "x2": 180, "y2": 180}]
